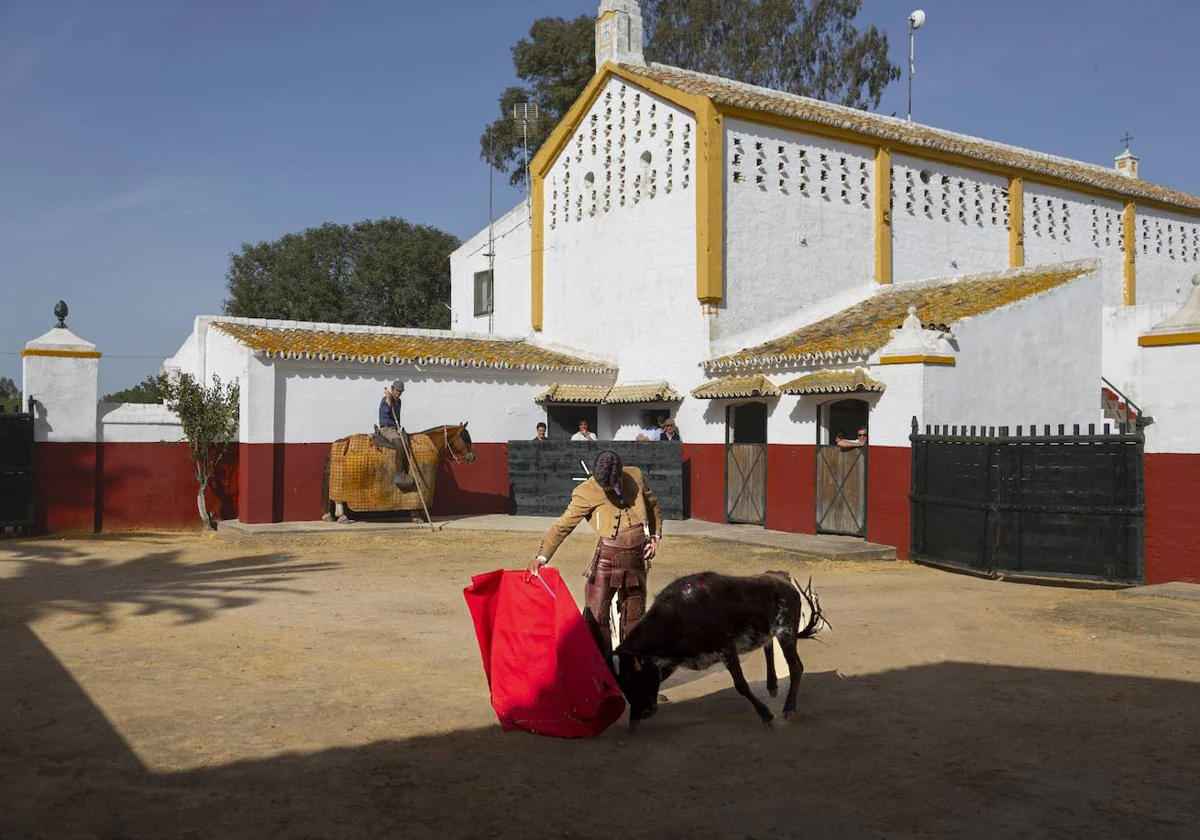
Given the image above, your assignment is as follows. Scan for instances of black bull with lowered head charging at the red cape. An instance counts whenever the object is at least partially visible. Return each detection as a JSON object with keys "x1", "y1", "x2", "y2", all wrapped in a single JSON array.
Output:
[{"x1": 612, "y1": 571, "x2": 826, "y2": 730}]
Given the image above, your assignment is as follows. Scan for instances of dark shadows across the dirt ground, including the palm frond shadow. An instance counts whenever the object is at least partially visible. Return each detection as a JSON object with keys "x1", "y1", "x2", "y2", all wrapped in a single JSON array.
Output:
[{"x1": 0, "y1": 546, "x2": 1200, "y2": 838}]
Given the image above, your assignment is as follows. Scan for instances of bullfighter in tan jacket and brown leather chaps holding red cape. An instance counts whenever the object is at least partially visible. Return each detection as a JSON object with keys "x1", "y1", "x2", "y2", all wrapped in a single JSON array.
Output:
[{"x1": 526, "y1": 449, "x2": 662, "y2": 661}]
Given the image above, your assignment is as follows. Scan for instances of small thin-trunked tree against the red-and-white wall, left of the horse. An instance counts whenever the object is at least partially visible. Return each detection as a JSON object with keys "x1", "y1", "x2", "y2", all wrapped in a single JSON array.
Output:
[{"x1": 154, "y1": 373, "x2": 241, "y2": 528}]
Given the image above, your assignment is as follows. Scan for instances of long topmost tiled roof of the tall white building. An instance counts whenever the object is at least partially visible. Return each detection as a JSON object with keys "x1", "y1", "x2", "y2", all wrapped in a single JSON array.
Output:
[{"x1": 620, "y1": 64, "x2": 1200, "y2": 210}]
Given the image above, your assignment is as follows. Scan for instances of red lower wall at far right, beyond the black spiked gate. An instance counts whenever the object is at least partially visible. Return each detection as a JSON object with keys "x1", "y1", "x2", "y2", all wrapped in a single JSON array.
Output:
[{"x1": 1145, "y1": 454, "x2": 1200, "y2": 583}]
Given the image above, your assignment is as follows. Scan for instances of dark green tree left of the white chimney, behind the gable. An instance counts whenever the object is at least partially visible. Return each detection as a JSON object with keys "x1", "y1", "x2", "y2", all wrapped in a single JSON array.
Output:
[{"x1": 479, "y1": 14, "x2": 595, "y2": 186}]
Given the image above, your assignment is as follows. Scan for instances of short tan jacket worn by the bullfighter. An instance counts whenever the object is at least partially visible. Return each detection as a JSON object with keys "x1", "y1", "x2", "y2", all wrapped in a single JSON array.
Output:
[{"x1": 538, "y1": 467, "x2": 662, "y2": 559}]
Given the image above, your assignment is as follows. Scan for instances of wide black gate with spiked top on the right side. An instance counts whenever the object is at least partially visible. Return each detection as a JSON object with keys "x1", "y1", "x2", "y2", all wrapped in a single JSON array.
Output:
[{"x1": 908, "y1": 418, "x2": 1145, "y2": 582}]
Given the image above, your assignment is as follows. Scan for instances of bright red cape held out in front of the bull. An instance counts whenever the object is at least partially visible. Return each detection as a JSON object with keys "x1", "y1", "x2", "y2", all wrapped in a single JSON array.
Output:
[{"x1": 463, "y1": 568, "x2": 625, "y2": 738}]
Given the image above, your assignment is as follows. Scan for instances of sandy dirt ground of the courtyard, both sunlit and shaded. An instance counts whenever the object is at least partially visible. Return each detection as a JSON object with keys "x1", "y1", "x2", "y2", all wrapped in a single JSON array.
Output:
[{"x1": 0, "y1": 532, "x2": 1200, "y2": 840}]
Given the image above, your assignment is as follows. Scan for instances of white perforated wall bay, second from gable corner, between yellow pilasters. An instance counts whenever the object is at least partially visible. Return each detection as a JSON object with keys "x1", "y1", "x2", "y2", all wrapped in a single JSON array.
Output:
[{"x1": 892, "y1": 155, "x2": 1009, "y2": 283}]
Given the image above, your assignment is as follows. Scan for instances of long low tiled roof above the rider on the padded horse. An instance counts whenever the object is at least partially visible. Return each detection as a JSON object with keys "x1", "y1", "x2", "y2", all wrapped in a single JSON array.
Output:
[{"x1": 212, "y1": 320, "x2": 614, "y2": 373}]
